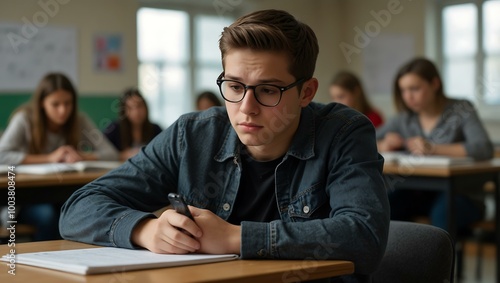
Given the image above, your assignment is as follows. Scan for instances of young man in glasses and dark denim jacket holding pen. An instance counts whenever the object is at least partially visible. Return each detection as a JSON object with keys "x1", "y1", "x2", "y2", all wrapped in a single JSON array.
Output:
[{"x1": 60, "y1": 10, "x2": 389, "y2": 282}]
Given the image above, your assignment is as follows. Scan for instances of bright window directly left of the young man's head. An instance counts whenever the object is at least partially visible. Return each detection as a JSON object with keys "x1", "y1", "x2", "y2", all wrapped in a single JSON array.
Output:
[{"x1": 137, "y1": 7, "x2": 234, "y2": 128}]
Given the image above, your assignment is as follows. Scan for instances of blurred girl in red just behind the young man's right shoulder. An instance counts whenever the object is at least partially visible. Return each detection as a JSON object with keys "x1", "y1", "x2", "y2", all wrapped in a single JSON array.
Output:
[{"x1": 329, "y1": 71, "x2": 384, "y2": 127}]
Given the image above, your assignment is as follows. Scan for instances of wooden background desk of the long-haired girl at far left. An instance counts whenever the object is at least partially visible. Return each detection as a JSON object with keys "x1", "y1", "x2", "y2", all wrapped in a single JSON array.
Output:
[{"x1": 0, "y1": 170, "x2": 108, "y2": 205}]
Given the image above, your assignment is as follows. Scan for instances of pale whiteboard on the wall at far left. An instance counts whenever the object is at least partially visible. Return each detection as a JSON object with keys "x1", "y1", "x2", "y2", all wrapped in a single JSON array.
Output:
[{"x1": 0, "y1": 22, "x2": 78, "y2": 91}]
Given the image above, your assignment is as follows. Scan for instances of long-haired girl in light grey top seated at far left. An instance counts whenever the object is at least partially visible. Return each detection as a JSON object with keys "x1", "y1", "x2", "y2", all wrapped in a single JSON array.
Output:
[{"x1": 0, "y1": 73, "x2": 118, "y2": 240}]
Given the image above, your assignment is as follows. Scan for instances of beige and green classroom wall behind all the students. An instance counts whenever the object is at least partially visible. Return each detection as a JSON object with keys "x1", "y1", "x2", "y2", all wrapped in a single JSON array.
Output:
[{"x1": 0, "y1": 0, "x2": 500, "y2": 142}]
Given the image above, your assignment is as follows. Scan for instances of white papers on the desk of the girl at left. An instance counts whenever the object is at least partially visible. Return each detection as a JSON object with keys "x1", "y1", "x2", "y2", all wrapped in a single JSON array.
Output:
[{"x1": 13, "y1": 161, "x2": 122, "y2": 175}]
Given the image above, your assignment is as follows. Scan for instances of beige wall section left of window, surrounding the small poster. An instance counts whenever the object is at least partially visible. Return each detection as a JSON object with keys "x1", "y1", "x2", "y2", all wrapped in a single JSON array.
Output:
[{"x1": 0, "y1": 0, "x2": 138, "y2": 94}]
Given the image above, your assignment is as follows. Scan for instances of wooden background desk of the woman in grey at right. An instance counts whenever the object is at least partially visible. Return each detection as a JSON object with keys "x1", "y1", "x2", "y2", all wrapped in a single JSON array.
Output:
[{"x1": 384, "y1": 158, "x2": 500, "y2": 283}]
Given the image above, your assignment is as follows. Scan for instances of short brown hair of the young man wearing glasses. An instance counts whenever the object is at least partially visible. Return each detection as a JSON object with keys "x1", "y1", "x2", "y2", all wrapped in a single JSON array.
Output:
[{"x1": 219, "y1": 9, "x2": 319, "y2": 79}]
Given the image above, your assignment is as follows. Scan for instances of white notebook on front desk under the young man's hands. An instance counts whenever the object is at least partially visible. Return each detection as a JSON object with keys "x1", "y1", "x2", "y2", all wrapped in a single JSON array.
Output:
[{"x1": 2, "y1": 247, "x2": 238, "y2": 274}]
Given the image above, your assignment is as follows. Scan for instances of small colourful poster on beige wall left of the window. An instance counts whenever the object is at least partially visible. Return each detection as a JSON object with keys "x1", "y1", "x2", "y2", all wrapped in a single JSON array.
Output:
[{"x1": 93, "y1": 33, "x2": 123, "y2": 73}]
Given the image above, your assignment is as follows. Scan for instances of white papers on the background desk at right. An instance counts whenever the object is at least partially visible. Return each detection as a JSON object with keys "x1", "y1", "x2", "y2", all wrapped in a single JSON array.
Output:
[{"x1": 380, "y1": 152, "x2": 474, "y2": 167}]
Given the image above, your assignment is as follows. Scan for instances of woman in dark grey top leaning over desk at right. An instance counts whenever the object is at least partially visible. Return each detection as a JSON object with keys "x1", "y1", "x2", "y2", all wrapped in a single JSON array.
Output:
[{"x1": 377, "y1": 58, "x2": 493, "y2": 231}]
